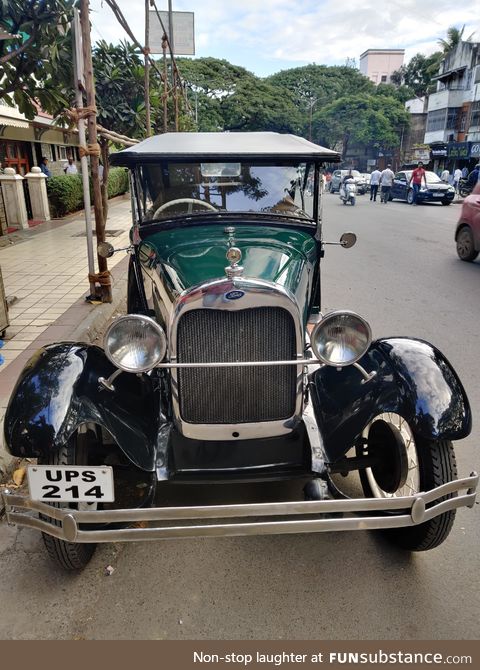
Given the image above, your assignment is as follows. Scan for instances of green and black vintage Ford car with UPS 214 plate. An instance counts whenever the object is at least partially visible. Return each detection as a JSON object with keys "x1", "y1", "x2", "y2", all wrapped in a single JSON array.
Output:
[{"x1": 4, "y1": 133, "x2": 478, "y2": 570}]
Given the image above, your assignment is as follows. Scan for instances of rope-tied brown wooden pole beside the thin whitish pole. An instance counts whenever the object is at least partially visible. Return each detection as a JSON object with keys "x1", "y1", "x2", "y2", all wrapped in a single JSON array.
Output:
[{"x1": 80, "y1": 0, "x2": 112, "y2": 302}]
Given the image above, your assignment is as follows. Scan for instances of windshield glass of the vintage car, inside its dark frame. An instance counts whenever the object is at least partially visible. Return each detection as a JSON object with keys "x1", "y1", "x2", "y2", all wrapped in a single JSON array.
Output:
[{"x1": 137, "y1": 161, "x2": 314, "y2": 222}]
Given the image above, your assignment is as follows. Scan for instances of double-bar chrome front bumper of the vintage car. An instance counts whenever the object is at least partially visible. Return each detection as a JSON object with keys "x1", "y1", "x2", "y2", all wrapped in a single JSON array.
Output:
[{"x1": 3, "y1": 472, "x2": 479, "y2": 542}]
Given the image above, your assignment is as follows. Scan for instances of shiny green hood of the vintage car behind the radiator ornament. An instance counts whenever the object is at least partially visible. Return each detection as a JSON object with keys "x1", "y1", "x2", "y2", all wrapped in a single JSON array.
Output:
[{"x1": 140, "y1": 224, "x2": 318, "y2": 314}]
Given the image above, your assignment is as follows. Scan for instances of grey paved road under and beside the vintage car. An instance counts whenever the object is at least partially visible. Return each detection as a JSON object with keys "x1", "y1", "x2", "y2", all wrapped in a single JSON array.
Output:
[{"x1": 0, "y1": 195, "x2": 480, "y2": 639}]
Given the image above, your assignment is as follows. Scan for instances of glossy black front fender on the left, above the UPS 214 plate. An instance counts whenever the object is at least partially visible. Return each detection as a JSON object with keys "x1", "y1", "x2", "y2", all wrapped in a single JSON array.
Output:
[{"x1": 4, "y1": 342, "x2": 160, "y2": 471}]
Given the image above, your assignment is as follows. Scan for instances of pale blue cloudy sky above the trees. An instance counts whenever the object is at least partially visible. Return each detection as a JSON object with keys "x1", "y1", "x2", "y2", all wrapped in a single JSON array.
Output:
[{"x1": 90, "y1": 0, "x2": 480, "y2": 77}]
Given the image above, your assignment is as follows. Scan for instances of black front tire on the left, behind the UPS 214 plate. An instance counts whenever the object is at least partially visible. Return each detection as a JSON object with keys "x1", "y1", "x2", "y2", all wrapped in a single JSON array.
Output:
[{"x1": 38, "y1": 431, "x2": 97, "y2": 572}]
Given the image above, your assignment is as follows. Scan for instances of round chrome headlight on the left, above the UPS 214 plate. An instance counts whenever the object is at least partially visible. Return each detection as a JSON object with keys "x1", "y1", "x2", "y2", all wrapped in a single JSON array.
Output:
[{"x1": 103, "y1": 314, "x2": 167, "y2": 372}]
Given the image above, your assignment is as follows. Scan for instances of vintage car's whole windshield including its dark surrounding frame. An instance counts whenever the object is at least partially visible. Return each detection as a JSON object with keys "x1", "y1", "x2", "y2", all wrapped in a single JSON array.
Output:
[{"x1": 131, "y1": 161, "x2": 321, "y2": 227}]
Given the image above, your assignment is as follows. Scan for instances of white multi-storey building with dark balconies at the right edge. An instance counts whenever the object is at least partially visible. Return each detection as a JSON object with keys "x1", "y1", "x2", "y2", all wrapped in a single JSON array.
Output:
[{"x1": 425, "y1": 42, "x2": 480, "y2": 172}]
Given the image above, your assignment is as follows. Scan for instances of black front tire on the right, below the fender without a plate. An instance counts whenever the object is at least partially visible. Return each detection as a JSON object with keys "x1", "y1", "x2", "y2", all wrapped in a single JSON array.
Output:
[{"x1": 360, "y1": 420, "x2": 457, "y2": 551}]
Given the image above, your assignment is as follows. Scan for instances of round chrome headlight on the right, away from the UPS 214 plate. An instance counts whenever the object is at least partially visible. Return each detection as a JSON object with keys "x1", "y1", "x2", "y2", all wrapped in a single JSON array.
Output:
[{"x1": 310, "y1": 311, "x2": 372, "y2": 367}]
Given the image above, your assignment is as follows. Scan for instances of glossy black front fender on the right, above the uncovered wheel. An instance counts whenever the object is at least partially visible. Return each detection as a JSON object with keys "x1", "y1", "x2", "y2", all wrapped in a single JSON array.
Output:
[{"x1": 310, "y1": 337, "x2": 472, "y2": 462}]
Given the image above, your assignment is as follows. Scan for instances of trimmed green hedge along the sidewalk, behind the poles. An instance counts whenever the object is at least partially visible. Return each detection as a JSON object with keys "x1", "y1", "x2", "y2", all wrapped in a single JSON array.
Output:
[{"x1": 47, "y1": 168, "x2": 128, "y2": 217}]
